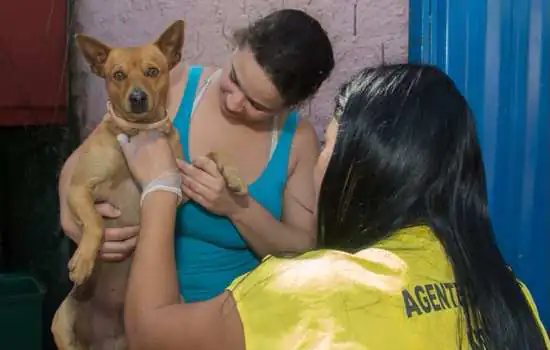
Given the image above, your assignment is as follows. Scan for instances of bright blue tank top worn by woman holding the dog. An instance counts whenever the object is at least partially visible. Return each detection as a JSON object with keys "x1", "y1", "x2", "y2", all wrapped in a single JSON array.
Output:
[{"x1": 174, "y1": 66, "x2": 298, "y2": 302}]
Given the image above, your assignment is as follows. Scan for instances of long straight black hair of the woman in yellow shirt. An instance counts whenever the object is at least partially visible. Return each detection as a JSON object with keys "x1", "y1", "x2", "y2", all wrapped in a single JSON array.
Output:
[{"x1": 318, "y1": 64, "x2": 546, "y2": 350}]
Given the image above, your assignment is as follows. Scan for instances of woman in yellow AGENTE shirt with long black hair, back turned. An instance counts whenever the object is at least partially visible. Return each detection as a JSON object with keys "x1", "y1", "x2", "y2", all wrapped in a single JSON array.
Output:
[{"x1": 120, "y1": 65, "x2": 550, "y2": 350}]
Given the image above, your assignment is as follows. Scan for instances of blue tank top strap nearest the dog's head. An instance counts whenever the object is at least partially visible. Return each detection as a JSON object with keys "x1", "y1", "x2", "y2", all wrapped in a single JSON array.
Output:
[{"x1": 173, "y1": 66, "x2": 203, "y2": 161}]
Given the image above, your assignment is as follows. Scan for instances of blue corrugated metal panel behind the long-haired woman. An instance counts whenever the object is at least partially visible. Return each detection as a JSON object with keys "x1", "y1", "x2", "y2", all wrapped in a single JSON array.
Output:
[{"x1": 409, "y1": 0, "x2": 550, "y2": 327}]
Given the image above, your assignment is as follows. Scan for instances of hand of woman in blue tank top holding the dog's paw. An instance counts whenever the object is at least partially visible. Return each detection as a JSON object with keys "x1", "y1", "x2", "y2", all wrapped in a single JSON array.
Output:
[{"x1": 177, "y1": 157, "x2": 248, "y2": 216}]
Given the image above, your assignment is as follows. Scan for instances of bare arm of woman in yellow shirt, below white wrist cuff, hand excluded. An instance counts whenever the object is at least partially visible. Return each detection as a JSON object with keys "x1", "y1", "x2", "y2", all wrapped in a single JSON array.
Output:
[{"x1": 124, "y1": 191, "x2": 244, "y2": 350}]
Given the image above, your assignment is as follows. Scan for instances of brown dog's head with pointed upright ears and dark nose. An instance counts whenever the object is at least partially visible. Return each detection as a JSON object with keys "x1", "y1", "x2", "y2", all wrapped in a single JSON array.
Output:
[{"x1": 76, "y1": 20, "x2": 184, "y2": 122}]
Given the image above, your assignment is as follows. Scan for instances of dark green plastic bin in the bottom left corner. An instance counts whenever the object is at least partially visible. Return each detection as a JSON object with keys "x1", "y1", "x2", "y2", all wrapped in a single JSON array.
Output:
[{"x1": 0, "y1": 273, "x2": 45, "y2": 350}]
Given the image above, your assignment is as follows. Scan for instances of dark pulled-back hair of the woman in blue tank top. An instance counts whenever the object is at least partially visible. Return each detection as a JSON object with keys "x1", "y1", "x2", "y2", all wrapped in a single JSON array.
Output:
[{"x1": 234, "y1": 9, "x2": 334, "y2": 106}]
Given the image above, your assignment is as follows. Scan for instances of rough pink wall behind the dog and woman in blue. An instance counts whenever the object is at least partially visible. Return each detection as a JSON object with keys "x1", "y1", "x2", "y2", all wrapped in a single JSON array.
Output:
[{"x1": 74, "y1": 0, "x2": 408, "y2": 138}]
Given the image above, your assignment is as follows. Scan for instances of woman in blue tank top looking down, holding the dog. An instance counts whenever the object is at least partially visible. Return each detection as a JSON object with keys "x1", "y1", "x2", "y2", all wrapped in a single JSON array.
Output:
[{"x1": 60, "y1": 10, "x2": 334, "y2": 302}]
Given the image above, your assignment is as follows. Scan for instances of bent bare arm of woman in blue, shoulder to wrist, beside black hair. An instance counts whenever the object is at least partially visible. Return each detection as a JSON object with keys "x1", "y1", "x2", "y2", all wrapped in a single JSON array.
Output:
[{"x1": 229, "y1": 120, "x2": 319, "y2": 257}]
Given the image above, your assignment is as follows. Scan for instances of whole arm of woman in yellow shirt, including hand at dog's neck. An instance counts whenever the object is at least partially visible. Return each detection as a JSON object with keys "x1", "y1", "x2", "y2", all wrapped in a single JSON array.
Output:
[{"x1": 117, "y1": 131, "x2": 244, "y2": 350}]
